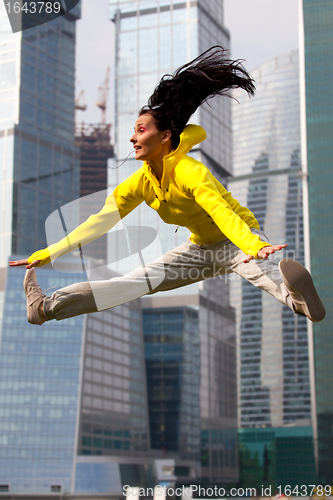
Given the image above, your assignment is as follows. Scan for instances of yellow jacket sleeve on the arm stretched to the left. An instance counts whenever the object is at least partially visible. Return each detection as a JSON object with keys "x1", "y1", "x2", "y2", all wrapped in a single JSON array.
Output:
[{"x1": 28, "y1": 169, "x2": 144, "y2": 267}]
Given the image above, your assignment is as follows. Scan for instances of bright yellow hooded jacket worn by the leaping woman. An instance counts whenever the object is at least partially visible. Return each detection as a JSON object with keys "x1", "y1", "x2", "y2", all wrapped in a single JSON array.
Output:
[{"x1": 28, "y1": 125, "x2": 267, "y2": 266}]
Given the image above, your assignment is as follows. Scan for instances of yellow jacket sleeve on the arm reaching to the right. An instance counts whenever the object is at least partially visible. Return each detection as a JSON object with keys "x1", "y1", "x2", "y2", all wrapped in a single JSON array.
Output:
[{"x1": 187, "y1": 164, "x2": 269, "y2": 257}]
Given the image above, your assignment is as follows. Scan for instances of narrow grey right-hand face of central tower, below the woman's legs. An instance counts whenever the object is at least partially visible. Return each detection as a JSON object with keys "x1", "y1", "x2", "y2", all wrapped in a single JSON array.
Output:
[{"x1": 199, "y1": 277, "x2": 239, "y2": 484}]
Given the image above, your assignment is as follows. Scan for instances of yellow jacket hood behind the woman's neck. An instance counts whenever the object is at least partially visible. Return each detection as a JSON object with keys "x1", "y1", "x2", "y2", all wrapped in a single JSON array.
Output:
[{"x1": 144, "y1": 125, "x2": 207, "y2": 185}]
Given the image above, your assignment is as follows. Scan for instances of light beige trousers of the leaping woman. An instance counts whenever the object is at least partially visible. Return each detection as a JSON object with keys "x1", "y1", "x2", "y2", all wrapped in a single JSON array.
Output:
[{"x1": 44, "y1": 229, "x2": 292, "y2": 321}]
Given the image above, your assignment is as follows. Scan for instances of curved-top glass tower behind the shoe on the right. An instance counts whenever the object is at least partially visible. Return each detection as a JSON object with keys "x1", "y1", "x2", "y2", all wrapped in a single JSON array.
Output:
[{"x1": 228, "y1": 51, "x2": 315, "y2": 486}]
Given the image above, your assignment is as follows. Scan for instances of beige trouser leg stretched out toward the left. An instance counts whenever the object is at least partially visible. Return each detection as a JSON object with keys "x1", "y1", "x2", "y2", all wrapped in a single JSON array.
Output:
[{"x1": 44, "y1": 240, "x2": 214, "y2": 321}]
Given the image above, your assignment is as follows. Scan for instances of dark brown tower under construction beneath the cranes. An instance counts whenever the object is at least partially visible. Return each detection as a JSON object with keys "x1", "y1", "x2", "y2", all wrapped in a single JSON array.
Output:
[{"x1": 75, "y1": 123, "x2": 113, "y2": 261}]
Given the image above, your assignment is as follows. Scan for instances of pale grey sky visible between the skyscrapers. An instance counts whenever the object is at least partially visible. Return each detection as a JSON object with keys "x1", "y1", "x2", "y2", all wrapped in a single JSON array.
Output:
[{"x1": 76, "y1": 0, "x2": 298, "y2": 127}]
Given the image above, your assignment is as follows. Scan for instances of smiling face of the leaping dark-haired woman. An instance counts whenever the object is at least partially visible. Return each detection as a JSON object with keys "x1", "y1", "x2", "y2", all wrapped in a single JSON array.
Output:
[{"x1": 130, "y1": 113, "x2": 170, "y2": 161}]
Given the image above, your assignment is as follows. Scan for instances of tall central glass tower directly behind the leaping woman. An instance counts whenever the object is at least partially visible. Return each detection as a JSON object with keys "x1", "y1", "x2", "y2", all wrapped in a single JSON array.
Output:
[{"x1": 110, "y1": 0, "x2": 238, "y2": 483}]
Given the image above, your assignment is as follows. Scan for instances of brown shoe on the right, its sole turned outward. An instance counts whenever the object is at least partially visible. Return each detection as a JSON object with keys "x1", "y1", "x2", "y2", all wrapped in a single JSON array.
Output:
[{"x1": 279, "y1": 259, "x2": 326, "y2": 322}]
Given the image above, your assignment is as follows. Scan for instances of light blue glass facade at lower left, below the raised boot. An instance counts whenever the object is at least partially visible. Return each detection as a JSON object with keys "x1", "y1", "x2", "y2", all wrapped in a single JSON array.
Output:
[{"x1": 0, "y1": 268, "x2": 84, "y2": 493}]
